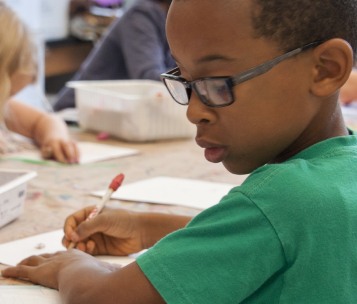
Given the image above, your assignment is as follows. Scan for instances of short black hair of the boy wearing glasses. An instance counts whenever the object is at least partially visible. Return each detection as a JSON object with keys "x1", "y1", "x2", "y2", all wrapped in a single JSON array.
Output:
[{"x1": 252, "y1": 0, "x2": 357, "y2": 57}]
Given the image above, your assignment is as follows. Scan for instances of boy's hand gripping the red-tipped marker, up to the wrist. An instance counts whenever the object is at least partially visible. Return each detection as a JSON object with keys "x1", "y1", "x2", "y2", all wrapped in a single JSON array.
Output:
[{"x1": 62, "y1": 206, "x2": 145, "y2": 255}]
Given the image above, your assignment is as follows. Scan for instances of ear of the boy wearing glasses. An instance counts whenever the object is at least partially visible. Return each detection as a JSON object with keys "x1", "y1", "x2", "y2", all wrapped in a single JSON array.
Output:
[{"x1": 310, "y1": 38, "x2": 353, "y2": 97}]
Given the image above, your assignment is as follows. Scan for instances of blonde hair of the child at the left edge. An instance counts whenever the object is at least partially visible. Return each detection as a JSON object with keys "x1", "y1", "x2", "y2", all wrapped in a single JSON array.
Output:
[{"x1": 0, "y1": 0, "x2": 37, "y2": 110}]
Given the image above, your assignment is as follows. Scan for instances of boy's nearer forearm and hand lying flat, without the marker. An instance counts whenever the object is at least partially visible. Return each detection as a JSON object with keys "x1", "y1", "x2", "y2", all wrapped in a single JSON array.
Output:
[{"x1": 2, "y1": 250, "x2": 165, "y2": 304}]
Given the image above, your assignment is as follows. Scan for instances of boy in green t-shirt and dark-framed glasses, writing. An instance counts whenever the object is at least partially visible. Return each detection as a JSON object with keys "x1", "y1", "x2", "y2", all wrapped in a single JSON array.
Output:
[{"x1": 3, "y1": 0, "x2": 357, "y2": 304}]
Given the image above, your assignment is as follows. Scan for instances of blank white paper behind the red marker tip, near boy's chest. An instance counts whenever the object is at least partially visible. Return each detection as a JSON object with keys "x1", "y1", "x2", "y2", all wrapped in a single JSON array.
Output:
[{"x1": 92, "y1": 176, "x2": 237, "y2": 209}]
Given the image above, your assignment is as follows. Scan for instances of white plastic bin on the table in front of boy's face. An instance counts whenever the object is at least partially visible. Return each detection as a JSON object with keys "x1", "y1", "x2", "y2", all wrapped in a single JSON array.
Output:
[{"x1": 68, "y1": 80, "x2": 195, "y2": 142}]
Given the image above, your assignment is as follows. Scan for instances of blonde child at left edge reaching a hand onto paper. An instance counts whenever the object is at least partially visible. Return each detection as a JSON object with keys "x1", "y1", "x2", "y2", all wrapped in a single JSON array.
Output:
[{"x1": 0, "y1": 2, "x2": 79, "y2": 163}]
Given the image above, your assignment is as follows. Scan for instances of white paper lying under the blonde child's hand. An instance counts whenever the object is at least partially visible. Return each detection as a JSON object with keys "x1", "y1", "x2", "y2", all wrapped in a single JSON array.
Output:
[{"x1": 2, "y1": 141, "x2": 139, "y2": 164}]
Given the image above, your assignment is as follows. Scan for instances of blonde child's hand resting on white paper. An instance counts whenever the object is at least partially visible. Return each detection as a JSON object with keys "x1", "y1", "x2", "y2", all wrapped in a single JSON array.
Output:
[{"x1": 41, "y1": 138, "x2": 79, "y2": 164}]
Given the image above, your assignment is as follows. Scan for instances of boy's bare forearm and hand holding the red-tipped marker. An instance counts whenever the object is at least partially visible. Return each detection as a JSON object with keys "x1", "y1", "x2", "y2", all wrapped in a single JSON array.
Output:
[{"x1": 63, "y1": 206, "x2": 191, "y2": 255}]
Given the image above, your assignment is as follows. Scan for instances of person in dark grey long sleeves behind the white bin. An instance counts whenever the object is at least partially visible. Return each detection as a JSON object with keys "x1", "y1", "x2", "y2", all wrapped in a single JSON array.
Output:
[{"x1": 53, "y1": 0, "x2": 175, "y2": 111}]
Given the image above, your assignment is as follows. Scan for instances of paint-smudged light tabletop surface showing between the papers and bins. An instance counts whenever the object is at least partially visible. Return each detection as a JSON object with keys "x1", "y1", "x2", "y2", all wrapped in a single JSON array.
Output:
[{"x1": 0, "y1": 128, "x2": 244, "y2": 243}]
